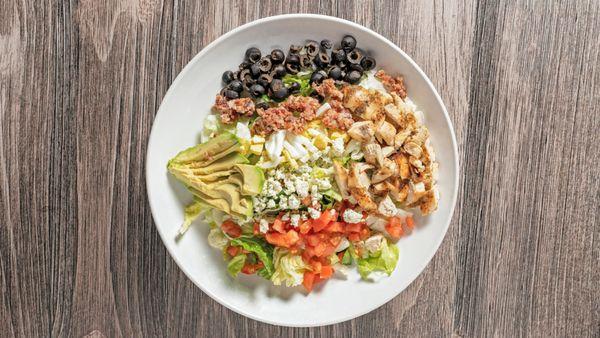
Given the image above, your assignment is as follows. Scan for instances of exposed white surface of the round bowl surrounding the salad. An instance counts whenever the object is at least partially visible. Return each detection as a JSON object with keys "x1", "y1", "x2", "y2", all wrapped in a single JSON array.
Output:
[{"x1": 146, "y1": 14, "x2": 458, "y2": 326}]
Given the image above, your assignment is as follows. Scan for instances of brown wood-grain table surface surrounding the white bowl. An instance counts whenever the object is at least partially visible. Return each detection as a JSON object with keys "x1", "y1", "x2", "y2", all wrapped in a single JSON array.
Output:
[{"x1": 0, "y1": 0, "x2": 600, "y2": 337}]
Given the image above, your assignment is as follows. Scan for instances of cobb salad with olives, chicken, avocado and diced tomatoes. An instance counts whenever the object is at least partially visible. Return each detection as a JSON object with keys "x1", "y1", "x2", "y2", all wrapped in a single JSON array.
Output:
[{"x1": 167, "y1": 35, "x2": 439, "y2": 292}]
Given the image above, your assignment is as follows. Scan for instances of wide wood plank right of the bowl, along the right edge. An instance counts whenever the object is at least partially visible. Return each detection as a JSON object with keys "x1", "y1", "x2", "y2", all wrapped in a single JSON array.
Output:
[{"x1": 455, "y1": 1, "x2": 600, "y2": 336}]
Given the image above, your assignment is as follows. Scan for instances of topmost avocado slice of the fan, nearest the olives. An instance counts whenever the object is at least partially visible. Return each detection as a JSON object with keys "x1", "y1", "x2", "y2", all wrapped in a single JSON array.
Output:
[{"x1": 168, "y1": 133, "x2": 241, "y2": 167}]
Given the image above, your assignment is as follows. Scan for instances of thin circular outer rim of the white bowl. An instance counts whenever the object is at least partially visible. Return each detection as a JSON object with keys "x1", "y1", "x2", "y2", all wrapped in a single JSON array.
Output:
[{"x1": 145, "y1": 13, "x2": 460, "y2": 327}]
